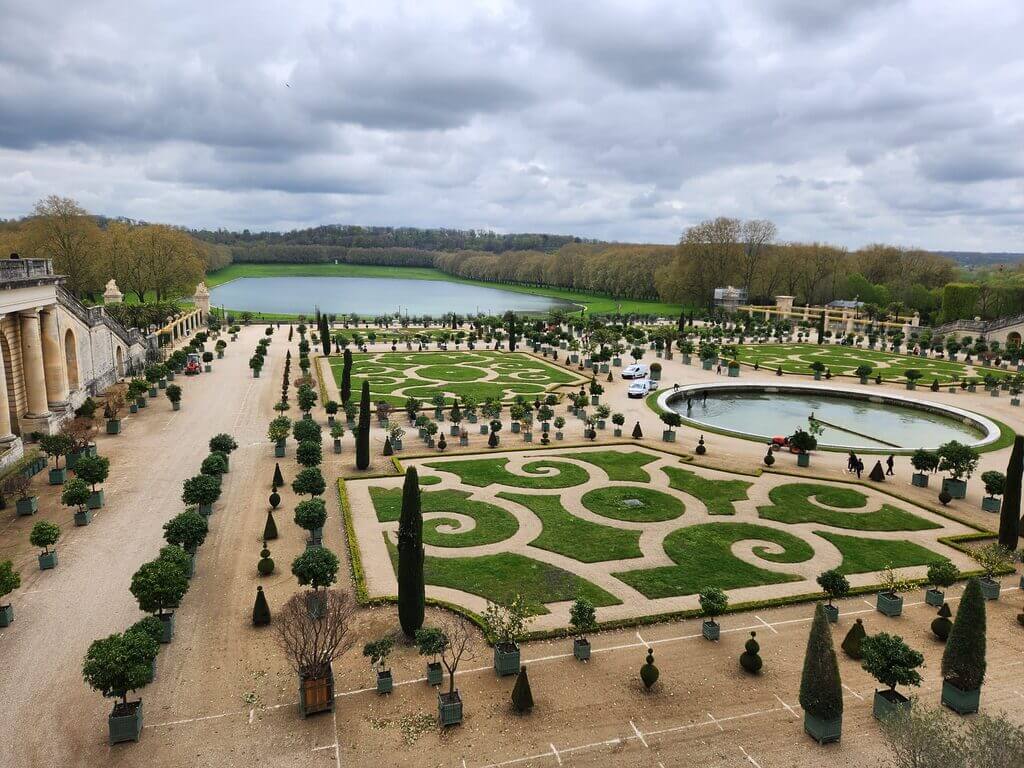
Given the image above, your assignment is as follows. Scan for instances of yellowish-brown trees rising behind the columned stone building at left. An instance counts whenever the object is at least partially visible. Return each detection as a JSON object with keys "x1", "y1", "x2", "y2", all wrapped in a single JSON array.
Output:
[{"x1": 0, "y1": 196, "x2": 230, "y2": 301}]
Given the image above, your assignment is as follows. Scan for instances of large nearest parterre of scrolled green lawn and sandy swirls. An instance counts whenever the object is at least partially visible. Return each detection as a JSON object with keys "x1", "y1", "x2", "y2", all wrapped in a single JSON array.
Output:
[{"x1": 354, "y1": 449, "x2": 966, "y2": 615}]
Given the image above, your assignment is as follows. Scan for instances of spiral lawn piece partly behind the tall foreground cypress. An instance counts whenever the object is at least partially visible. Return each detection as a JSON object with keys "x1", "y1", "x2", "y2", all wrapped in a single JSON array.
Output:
[{"x1": 370, "y1": 487, "x2": 519, "y2": 547}]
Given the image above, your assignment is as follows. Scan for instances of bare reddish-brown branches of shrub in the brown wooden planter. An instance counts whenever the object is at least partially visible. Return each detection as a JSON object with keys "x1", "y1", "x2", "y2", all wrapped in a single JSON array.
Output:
[{"x1": 273, "y1": 590, "x2": 355, "y2": 679}]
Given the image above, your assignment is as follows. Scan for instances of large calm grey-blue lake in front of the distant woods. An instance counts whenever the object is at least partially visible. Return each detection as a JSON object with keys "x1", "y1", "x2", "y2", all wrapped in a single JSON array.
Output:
[{"x1": 210, "y1": 278, "x2": 578, "y2": 316}]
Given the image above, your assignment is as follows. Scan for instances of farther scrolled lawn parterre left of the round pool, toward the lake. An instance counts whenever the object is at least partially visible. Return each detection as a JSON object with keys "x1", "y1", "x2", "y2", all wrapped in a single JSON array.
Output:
[{"x1": 329, "y1": 350, "x2": 583, "y2": 408}]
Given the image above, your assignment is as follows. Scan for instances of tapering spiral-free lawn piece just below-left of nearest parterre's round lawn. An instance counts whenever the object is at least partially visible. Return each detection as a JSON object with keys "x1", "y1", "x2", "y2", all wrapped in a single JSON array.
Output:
[{"x1": 498, "y1": 492, "x2": 643, "y2": 562}]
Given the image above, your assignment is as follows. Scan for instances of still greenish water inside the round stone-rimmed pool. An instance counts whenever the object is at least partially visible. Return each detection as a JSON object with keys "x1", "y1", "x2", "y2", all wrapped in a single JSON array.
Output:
[{"x1": 672, "y1": 392, "x2": 983, "y2": 449}]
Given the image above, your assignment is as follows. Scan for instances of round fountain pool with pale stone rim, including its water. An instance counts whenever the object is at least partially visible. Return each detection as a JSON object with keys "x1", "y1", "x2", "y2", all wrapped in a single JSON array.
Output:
[{"x1": 658, "y1": 383, "x2": 999, "y2": 452}]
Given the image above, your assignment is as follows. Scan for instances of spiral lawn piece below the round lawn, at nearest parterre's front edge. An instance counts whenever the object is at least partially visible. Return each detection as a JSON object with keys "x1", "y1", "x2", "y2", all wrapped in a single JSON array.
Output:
[{"x1": 612, "y1": 522, "x2": 814, "y2": 600}]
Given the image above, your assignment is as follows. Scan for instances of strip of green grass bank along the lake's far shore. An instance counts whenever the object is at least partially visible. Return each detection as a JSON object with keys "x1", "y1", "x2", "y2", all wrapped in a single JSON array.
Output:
[{"x1": 206, "y1": 264, "x2": 683, "y2": 317}]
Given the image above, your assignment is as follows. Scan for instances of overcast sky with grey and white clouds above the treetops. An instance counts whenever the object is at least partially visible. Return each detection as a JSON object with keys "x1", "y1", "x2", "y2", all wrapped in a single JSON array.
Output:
[{"x1": 0, "y1": 0, "x2": 1024, "y2": 251}]
